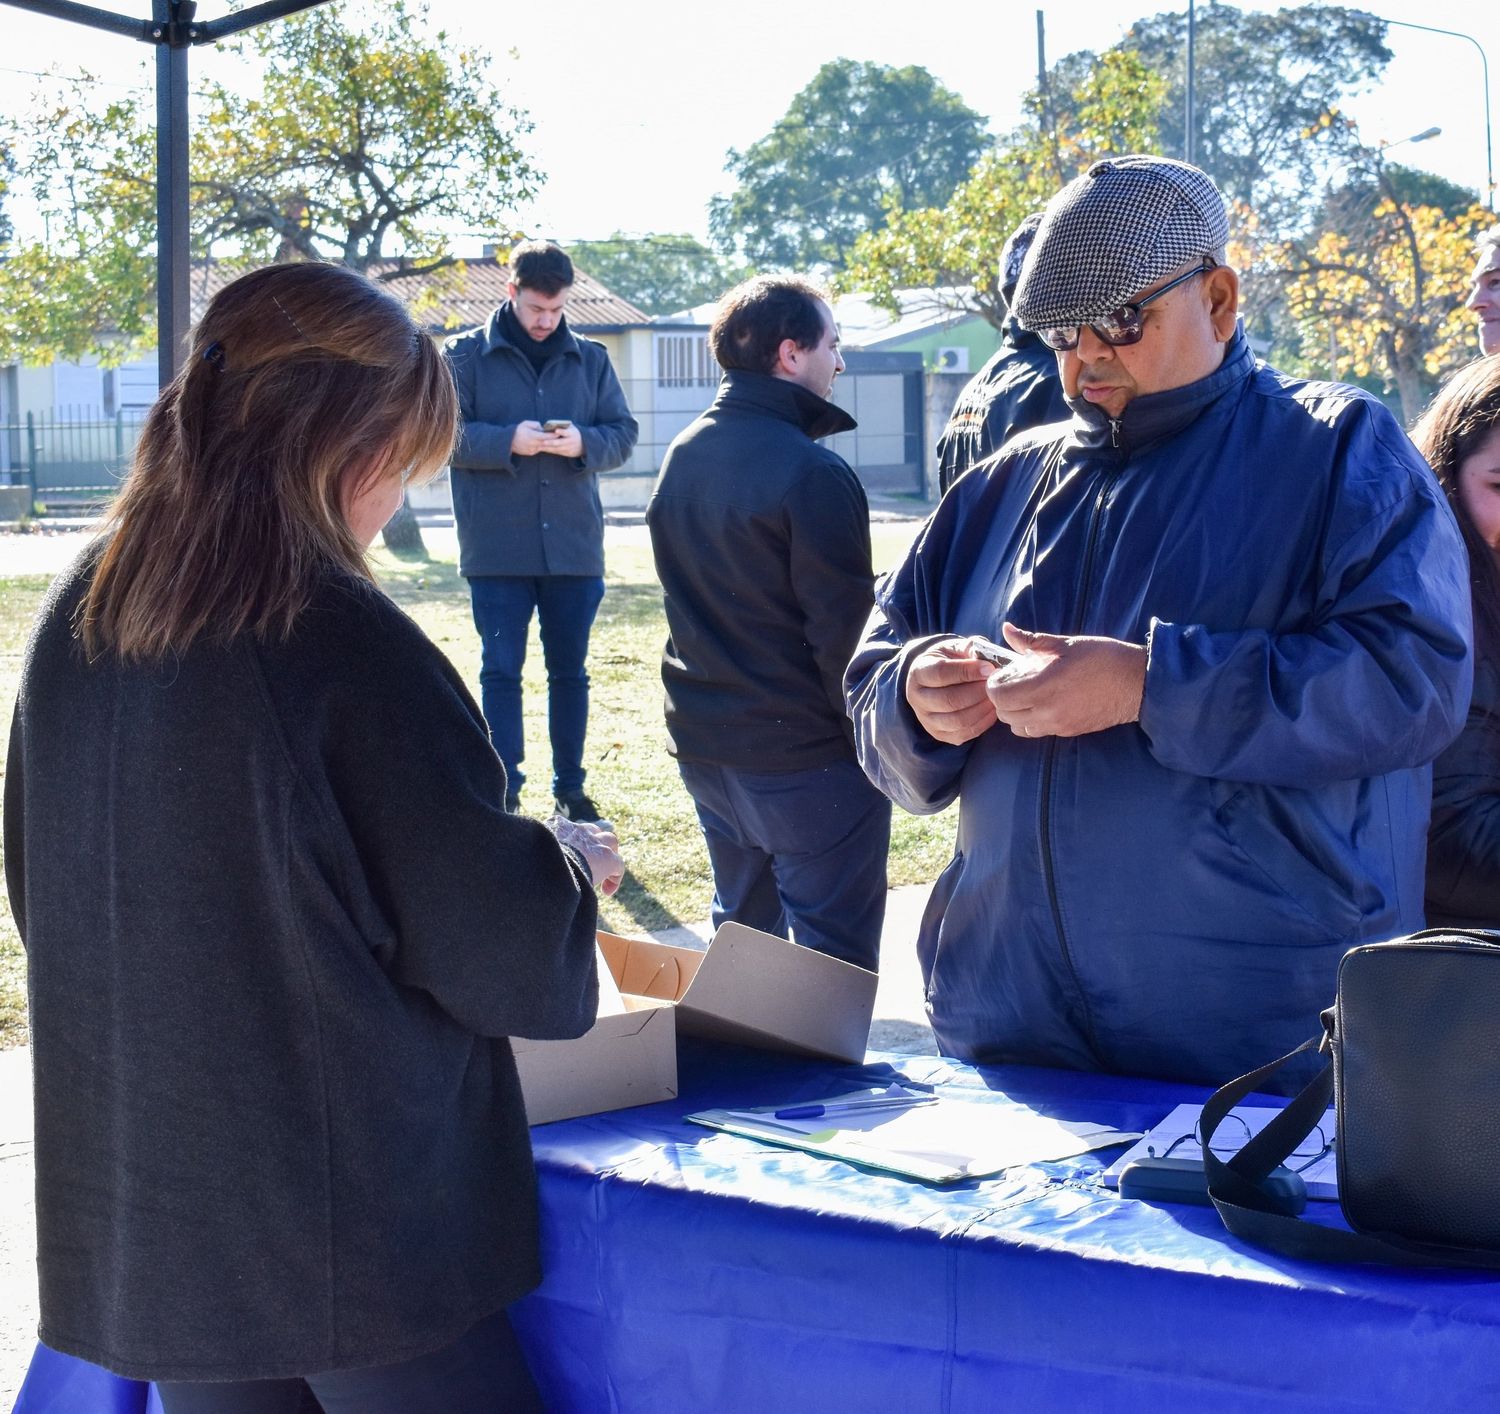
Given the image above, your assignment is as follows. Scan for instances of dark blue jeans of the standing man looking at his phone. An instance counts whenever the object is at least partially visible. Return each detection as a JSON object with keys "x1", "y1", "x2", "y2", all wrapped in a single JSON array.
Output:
[{"x1": 470, "y1": 574, "x2": 605, "y2": 796}]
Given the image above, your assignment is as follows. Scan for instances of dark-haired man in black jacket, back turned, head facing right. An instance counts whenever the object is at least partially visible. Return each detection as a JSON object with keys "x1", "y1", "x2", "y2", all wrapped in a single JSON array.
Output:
[{"x1": 647, "y1": 276, "x2": 891, "y2": 969}]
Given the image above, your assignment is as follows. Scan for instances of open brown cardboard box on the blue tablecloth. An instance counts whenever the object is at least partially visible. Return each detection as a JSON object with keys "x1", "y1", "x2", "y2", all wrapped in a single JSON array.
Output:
[{"x1": 512, "y1": 924, "x2": 879, "y2": 1125}]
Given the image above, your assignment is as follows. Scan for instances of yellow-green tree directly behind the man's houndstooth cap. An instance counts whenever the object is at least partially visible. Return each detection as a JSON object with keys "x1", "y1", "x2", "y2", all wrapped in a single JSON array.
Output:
[{"x1": 839, "y1": 51, "x2": 1164, "y2": 328}]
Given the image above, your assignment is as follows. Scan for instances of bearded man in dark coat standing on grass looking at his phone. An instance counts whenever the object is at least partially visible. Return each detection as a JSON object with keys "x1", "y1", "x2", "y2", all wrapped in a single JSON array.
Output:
[{"x1": 446, "y1": 241, "x2": 638, "y2": 822}]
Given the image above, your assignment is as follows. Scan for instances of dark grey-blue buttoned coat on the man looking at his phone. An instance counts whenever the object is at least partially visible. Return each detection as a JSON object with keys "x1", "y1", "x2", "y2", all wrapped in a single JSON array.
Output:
[{"x1": 444, "y1": 306, "x2": 639, "y2": 577}]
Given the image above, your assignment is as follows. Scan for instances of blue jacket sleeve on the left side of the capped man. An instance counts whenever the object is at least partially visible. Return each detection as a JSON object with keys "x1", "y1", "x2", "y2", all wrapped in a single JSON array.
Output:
[{"x1": 845, "y1": 478, "x2": 971, "y2": 816}]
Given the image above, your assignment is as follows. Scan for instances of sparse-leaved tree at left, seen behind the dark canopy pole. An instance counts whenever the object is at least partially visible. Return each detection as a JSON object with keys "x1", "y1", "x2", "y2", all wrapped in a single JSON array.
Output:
[{"x1": 0, "y1": 0, "x2": 539, "y2": 361}]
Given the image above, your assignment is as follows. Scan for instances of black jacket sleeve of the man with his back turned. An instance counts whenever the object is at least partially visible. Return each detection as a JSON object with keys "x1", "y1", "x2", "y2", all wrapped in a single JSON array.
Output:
[{"x1": 782, "y1": 460, "x2": 875, "y2": 744}]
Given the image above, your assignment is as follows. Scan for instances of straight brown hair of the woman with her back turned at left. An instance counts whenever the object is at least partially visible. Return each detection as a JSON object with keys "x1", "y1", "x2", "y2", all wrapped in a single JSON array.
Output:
[{"x1": 75, "y1": 264, "x2": 458, "y2": 660}]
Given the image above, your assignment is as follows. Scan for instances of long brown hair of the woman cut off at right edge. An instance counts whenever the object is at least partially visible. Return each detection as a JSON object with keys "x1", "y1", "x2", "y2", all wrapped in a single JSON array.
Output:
[{"x1": 1412, "y1": 355, "x2": 1500, "y2": 657}]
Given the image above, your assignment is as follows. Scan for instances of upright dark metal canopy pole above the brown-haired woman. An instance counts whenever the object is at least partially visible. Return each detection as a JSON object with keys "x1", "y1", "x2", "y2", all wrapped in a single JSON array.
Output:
[{"x1": 152, "y1": 0, "x2": 195, "y2": 388}]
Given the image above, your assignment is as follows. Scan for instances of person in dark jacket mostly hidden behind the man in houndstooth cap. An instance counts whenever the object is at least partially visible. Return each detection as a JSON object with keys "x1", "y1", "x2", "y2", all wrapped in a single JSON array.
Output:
[{"x1": 938, "y1": 211, "x2": 1073, "y2": 493}]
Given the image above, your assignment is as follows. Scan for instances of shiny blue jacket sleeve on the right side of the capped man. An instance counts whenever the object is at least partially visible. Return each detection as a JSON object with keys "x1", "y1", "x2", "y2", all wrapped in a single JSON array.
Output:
[{"x1": 1140, "y1": 423, "x2": 1472, "y2": 787}]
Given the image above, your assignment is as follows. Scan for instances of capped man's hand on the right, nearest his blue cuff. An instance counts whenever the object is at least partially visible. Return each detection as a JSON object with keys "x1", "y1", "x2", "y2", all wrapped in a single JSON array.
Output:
[{"x1": 986, "y1": 624, "x2": 1146, "y2": 736}]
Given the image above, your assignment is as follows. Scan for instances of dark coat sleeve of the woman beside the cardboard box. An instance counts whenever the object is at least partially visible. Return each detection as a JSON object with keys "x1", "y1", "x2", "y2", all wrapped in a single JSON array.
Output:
[{"x1": 286, "y1": 606, "x2": 597, "y2": 1039}]
